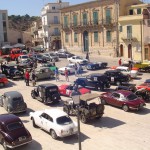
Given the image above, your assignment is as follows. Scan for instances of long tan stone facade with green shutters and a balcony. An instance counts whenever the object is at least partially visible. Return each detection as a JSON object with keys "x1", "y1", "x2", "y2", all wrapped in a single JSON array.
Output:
[{"x1": 61, "y1": 0, "x2": 117, "y2": 56}]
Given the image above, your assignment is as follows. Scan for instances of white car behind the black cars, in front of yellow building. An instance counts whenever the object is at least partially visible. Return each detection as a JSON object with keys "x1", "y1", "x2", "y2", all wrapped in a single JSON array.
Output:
[{"x1": 116, "y1": 66, "x2": 138, "y2": 78}]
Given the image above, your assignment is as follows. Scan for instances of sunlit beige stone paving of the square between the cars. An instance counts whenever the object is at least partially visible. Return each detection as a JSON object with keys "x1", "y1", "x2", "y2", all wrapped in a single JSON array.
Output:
[{"x1": 0, "y1": 54, "x2": 150, "y2": 150}]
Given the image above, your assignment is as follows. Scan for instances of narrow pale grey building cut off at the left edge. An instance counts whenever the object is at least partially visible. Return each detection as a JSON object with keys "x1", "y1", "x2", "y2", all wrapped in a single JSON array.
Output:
[{"x1": 0, "y1": 10, "x2": 8, "y2": 47}]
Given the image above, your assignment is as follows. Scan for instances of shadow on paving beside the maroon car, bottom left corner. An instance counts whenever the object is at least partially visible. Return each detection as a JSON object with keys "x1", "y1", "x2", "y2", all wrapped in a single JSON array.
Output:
[{"x1": 15, "y1": 140, "x2": 42, "y2": 150}]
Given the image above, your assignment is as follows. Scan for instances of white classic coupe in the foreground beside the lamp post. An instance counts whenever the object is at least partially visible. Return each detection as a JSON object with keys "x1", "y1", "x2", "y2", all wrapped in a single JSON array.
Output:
[{"x1": 30, "y1": 109, "x2": 78, "y2": 139}]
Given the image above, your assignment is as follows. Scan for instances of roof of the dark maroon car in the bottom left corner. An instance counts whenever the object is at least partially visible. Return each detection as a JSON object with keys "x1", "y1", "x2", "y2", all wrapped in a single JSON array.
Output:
[{"x1": 0, "y1": 114, "x2": 21, "y2": 124}]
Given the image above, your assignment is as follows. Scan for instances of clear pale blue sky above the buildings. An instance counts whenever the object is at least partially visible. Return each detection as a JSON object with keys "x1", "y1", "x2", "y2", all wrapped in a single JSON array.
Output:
[{"x1": 0, "y1": 0, "x2": 92, "y2": 16}]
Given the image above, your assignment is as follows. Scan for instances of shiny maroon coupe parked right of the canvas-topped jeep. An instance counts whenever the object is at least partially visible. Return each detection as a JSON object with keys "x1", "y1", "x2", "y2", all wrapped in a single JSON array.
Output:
[{"x1": 100, "y1": 90, "x2": 145, "y2": 112}]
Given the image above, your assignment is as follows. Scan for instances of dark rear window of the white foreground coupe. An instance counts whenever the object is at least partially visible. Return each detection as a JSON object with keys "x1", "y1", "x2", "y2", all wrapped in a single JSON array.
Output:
[{"x1": 56, "y1": 116, "x2": 72, "y2": 125}]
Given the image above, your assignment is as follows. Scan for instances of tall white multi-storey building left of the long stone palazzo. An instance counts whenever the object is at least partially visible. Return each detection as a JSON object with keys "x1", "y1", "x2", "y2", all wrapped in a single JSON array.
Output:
[{"x1": 41, "y1": 0, "x2": 69, "y2": 49}]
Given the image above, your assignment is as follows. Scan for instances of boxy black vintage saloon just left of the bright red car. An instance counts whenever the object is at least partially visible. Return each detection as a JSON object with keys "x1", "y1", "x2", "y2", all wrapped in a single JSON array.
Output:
[{"x1": 31, "y1": 83, "x2": 61, "y2": 104}]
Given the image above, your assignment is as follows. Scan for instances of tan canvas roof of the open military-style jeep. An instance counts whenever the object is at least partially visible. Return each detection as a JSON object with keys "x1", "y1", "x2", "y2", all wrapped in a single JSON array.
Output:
[{"x1": 80, "y1": 93, "x2": 100, "y2": 101}]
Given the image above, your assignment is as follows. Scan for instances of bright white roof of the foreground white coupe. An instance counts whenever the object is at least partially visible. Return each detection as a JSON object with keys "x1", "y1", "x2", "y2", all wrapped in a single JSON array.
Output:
[{"x1": 45, "y1": 108, "x2": 67, "y2": 119}]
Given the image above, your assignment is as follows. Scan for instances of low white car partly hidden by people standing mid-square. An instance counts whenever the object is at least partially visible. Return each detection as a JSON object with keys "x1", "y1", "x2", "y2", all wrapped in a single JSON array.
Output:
[{"x1": 58, "y1": 63, "x2": 83, "y2": 74}]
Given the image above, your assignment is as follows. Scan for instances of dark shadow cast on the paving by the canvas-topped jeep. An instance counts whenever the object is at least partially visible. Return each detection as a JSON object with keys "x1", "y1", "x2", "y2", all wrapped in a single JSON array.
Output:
[{"x1": 88, "y1": 117, "x2": 125, "y2": 128}]
